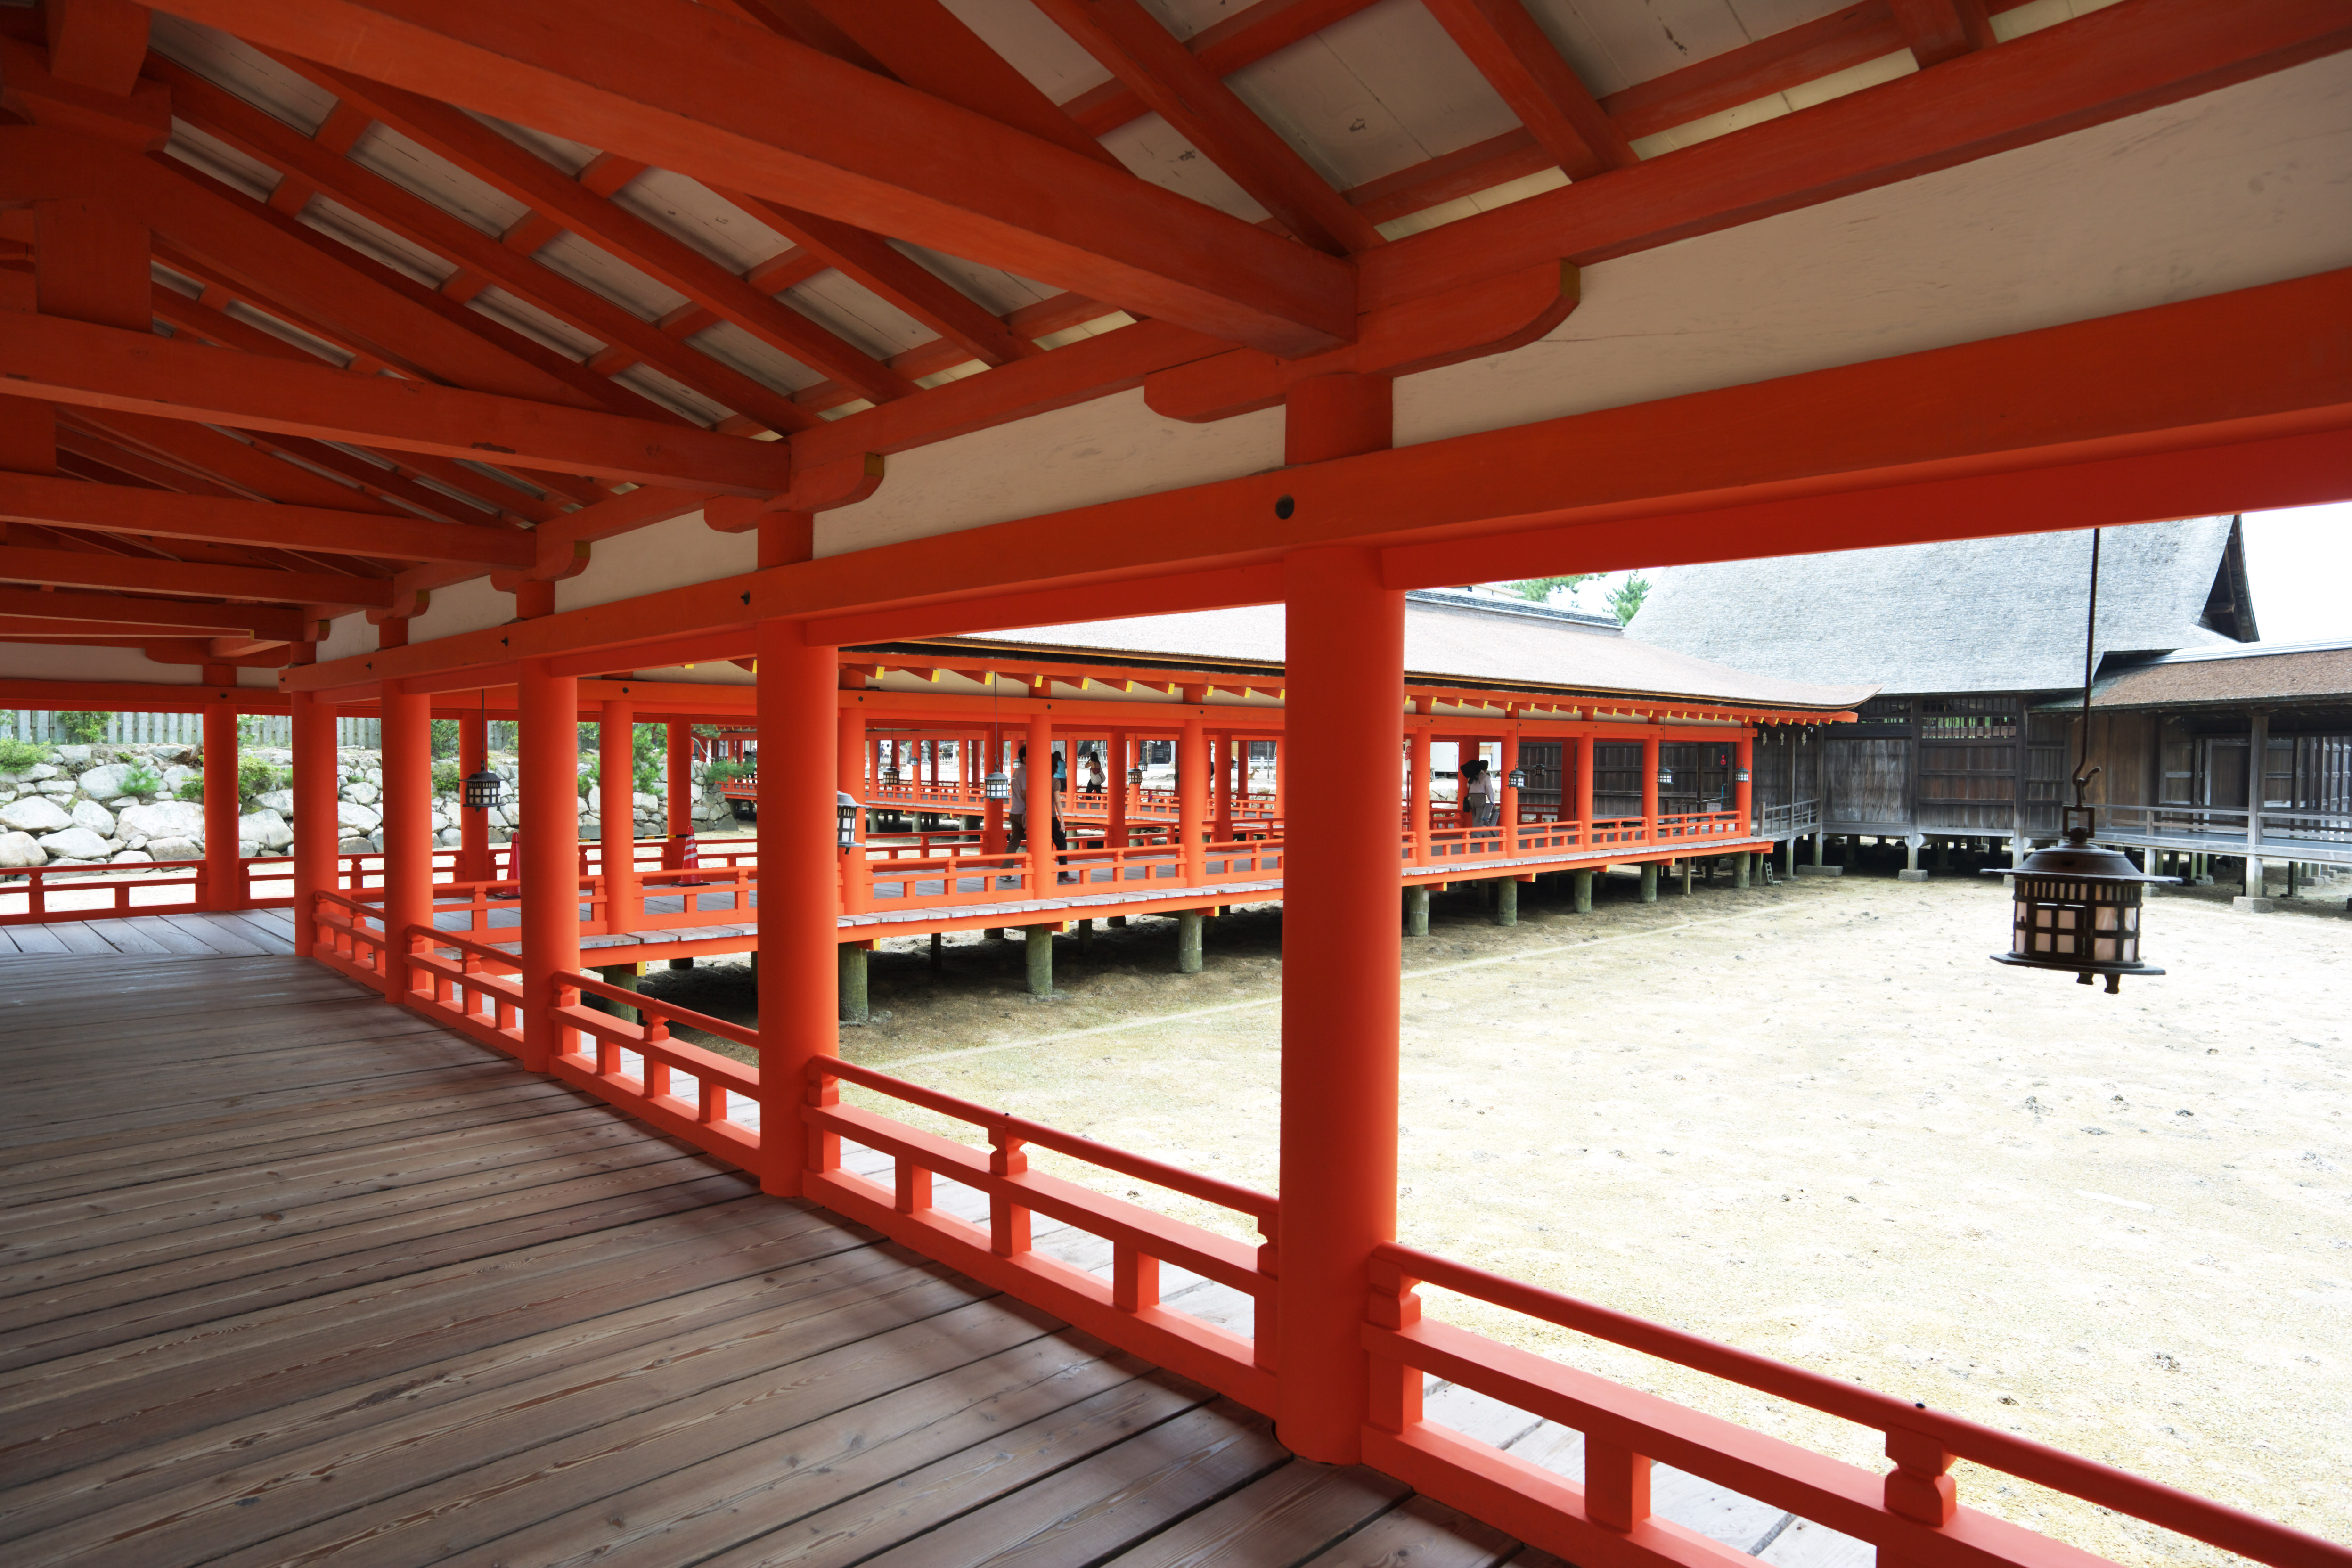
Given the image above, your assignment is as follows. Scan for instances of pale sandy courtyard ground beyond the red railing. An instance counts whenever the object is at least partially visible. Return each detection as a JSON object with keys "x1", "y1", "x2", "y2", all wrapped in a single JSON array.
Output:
[{"x1": 649, "y1": 874, "x2": 2352, "y2": 1563}]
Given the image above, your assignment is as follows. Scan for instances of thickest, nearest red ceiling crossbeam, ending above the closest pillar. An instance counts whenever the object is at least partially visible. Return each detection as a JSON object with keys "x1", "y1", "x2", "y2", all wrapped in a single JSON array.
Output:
[{"x1": 142, "y1": 0, "x2": 1355, "y2": 352}]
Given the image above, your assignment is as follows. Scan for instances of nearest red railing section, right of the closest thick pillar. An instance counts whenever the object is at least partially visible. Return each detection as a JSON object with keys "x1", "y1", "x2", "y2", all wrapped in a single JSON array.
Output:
[{"x1": 1364, "y1": 1246, "x2": 2352, "y2": 1568}]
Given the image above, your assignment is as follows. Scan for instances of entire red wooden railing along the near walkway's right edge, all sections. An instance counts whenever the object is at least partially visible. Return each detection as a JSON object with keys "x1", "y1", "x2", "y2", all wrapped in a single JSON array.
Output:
[{"x1": 357, "y1": 931, "x2": 2352, "y2": 1568}]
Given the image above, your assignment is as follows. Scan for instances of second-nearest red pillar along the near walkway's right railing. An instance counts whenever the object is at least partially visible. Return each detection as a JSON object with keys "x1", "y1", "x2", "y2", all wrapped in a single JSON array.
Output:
[{"x1": 755, "y1": 621, "x2": 837, "y2": 1197}]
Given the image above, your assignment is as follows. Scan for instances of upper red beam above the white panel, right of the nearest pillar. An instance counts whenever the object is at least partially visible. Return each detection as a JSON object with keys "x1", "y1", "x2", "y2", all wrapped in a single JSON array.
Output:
[{"x1": 1359, "y1": 0, "x2": 2352, "y2": 310}]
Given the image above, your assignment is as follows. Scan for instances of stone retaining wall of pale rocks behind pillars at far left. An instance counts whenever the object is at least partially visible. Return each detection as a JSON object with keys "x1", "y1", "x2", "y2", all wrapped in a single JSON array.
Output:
[{"x1": 0, "y1": 743, "x2": 729, "y2": 870}]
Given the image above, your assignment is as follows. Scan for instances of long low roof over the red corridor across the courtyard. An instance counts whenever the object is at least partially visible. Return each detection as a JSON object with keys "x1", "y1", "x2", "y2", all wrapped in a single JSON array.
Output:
[{"x1": 922, "y1": 588, "x2": 1872, "y2": 712}]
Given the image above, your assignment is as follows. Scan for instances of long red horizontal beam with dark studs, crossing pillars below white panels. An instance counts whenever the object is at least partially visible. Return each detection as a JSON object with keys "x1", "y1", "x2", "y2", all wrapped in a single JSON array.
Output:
[{"x1": 294, "y1": 268, "x2": 2352, "y2": 686}]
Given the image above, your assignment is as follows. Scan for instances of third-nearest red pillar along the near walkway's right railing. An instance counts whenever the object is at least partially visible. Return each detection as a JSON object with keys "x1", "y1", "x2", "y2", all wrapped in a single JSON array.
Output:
[{"x1": 515, "y1": 658, "x2": 581, "y2": 1072}]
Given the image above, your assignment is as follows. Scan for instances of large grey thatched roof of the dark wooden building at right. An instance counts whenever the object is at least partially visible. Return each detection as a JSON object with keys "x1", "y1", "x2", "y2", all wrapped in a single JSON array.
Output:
[{"x1": 1627, "y1": 517, "x2": 2255, "y2": 694}]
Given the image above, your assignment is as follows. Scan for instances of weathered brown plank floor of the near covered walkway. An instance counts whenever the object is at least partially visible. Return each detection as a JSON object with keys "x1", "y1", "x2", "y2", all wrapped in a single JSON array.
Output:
[{"x1": 0, "y1": 955, "x2": 1552, "y2": 1568}]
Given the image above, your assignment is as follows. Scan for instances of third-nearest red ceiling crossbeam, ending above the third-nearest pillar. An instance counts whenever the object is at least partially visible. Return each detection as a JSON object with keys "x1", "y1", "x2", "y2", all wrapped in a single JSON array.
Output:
[{"x1": 0, "y1": 473, "x2": 539, "y2": 566}]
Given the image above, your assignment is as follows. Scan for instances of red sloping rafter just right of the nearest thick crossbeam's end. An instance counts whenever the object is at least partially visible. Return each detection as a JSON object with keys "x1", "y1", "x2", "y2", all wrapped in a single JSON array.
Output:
[{"x1": 1037, "y1": 0, "x2": 1380, "y2": 254}]
